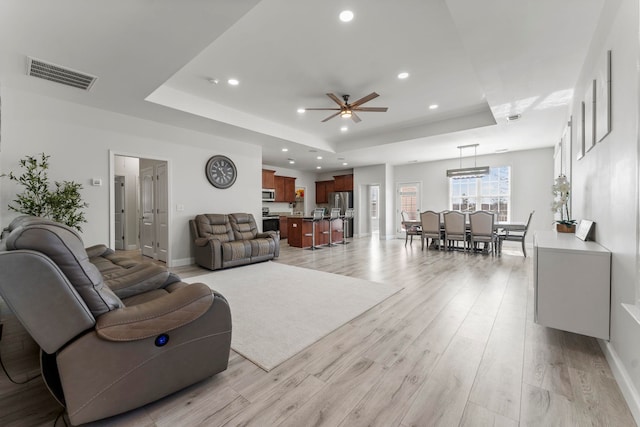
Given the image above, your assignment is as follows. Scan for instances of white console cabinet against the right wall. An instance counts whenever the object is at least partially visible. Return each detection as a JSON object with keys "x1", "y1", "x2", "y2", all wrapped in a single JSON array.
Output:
[{"x1": 533, "y1": 231, "x2": 611, "y2": 340}]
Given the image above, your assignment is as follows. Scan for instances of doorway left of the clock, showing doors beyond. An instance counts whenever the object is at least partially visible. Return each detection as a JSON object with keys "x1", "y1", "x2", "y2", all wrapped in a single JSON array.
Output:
[{"x1": 110, "y1": 153, "x2": 170, "y2": 266}]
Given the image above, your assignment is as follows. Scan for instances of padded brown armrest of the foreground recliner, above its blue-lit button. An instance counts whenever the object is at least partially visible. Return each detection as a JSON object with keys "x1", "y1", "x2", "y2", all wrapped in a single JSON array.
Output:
[{"x1": 96, "y1": 283, "x2": 214, "y2": 341}]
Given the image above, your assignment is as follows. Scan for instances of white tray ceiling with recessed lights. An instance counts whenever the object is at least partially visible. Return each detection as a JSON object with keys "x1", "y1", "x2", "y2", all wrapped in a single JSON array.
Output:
[{"x1": 0, "y1": 0, "x2": 604, "y2": 171}]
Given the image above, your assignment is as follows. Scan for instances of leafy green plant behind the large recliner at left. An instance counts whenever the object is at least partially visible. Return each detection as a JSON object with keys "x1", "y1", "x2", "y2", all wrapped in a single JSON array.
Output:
[{"x1": 0, "y1": 153, "x2": 87, "y2": 231}]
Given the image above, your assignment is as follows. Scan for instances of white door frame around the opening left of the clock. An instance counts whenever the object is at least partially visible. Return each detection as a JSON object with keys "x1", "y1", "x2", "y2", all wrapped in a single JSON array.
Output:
[{"x1": 109, "y1": 150, "x2": 173, "y2": 267}]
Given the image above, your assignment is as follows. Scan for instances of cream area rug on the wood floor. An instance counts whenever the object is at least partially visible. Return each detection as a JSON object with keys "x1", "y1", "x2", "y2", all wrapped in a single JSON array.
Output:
[{"x1": 184, "y1": 261, "x2": 402, "y2": 371}]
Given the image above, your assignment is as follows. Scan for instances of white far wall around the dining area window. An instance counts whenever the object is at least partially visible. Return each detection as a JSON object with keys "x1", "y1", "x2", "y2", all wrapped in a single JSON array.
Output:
[{"x1": 394, "y1": 147, "x2": 560, "y2": 242}]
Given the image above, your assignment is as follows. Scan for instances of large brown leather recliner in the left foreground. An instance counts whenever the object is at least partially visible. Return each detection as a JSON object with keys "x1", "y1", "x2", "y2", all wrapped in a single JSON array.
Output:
[{"x1": 0, "y1": 222, "x2": 231, "y2": 424}]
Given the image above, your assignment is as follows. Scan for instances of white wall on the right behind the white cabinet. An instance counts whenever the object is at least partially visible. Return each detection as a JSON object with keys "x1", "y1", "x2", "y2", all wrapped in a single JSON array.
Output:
[{"x1": 572, "y1": 0, "x2": 640, "y2": 422}]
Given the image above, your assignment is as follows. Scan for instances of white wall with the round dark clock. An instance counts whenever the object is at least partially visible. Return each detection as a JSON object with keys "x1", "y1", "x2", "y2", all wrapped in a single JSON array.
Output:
[{"x1": 0, "y1": 87, "x2": 262, "y2": 264}]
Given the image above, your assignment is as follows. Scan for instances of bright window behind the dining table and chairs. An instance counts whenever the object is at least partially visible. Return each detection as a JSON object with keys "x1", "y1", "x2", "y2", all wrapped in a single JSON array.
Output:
[{"x1": 449, "y1": 166, "x2": 511, "y2": 221}]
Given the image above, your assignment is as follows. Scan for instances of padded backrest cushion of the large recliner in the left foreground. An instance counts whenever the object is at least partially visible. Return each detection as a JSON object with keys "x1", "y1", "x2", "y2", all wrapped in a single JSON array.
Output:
[{"x1": 7, "y1": 223, "x2": 124, "y2": 318}]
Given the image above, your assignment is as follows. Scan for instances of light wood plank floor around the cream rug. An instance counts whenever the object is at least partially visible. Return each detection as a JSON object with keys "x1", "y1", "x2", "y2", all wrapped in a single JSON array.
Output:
[{"x1": 0, "y1": 238, "x2": 635, "y2": 427}]
